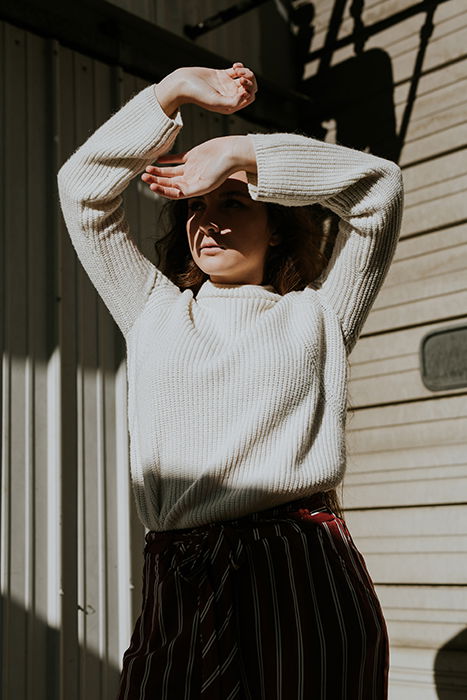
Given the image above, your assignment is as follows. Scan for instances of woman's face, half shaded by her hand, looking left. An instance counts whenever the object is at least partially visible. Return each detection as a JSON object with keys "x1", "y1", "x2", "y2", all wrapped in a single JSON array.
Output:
[{"x1": 186, "y1": 172, "x2": 279, "y2": 284}]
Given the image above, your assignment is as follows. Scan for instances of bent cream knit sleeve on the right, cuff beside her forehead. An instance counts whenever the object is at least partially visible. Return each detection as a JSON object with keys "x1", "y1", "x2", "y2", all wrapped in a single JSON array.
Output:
[{"x1": 248, "y1": 134, "x2": 403, "y2": 352}]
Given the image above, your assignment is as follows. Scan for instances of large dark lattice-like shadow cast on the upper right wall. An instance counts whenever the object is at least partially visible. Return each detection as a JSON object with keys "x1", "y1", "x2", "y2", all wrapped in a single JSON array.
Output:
[{"x1": 283, "y1": 0, "x2": 442, "y2": 162}]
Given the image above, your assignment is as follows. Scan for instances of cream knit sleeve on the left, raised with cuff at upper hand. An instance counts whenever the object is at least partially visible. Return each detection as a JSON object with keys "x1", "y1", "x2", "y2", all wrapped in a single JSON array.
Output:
[{"x1": 58, "y1": 85, "x2": 183, "y2": 335}]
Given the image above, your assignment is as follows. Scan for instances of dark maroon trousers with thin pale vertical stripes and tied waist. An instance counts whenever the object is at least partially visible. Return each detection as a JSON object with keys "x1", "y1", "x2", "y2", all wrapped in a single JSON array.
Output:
[{"x1": 118, "y1": 494, "x2": 389, "y2": 700}]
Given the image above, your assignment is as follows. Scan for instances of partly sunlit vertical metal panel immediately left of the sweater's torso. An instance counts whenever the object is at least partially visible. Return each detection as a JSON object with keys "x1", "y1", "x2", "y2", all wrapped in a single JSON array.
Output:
[{"x1": 94, "y1": 63, "x2": 127, "y2": 697}]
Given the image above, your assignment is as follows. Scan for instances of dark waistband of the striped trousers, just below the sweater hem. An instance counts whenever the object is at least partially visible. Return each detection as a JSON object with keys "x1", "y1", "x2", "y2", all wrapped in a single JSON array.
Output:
[{"x1": 146, "y1": 491, "x2": 329, "y2": 545}]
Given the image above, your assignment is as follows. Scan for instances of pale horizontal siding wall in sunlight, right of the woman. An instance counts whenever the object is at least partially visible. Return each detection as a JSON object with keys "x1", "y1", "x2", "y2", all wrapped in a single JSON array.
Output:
[{"x1": 304, "y1": 0, "x2": 467, "y2": 700}]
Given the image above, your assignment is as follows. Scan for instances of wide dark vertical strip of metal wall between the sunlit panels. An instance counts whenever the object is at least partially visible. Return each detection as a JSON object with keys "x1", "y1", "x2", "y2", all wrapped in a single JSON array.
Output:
[{"x1": 54, "y1": 39, "x2": 79, "y2": 700}]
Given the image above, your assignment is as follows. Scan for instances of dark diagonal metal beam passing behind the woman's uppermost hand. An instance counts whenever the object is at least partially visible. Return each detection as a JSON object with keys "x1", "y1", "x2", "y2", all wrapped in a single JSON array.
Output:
[{"x1": 0, "y1": 0, "x2": 316, "y2": 131}]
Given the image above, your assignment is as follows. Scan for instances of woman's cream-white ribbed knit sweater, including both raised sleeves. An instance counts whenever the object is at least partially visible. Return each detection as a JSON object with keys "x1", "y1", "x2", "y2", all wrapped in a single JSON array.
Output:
[{"x1": 59, "y1": 86, "x2": 402, "y2": 530}]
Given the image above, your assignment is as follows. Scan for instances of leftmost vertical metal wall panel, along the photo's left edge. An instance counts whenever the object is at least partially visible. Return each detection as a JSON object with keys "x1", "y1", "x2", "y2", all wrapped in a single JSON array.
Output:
[{"x1": 3, "y1": 21, "x2": 30, "y2": 697}]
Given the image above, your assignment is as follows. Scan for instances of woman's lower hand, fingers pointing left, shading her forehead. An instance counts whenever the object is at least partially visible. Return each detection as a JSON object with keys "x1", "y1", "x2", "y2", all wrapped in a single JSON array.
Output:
[{"x1": 141, "y1": 136, "x2": 256, "y2": 199}]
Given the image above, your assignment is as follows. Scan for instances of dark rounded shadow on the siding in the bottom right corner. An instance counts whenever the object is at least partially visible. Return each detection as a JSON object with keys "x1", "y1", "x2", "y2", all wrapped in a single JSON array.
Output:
[{"x1": 434, "y1": 629, "x2": 467, "y2": 700}]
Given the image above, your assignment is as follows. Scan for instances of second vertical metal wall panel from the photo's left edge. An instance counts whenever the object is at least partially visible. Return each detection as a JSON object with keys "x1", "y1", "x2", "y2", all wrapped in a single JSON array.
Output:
[{"x1": 24, "y1": 27, "x2": 53, "y2": 700}]
